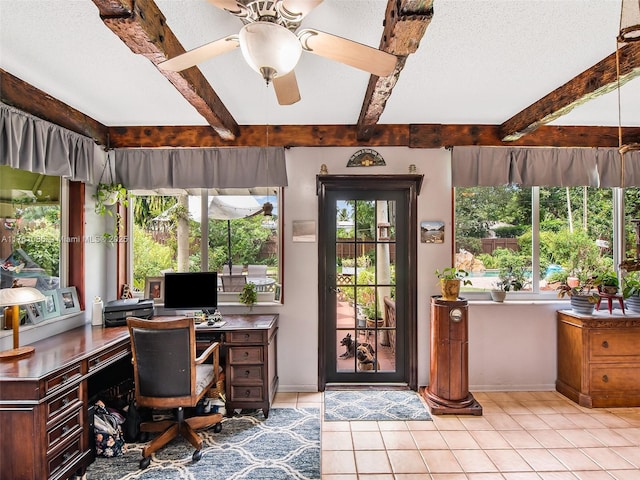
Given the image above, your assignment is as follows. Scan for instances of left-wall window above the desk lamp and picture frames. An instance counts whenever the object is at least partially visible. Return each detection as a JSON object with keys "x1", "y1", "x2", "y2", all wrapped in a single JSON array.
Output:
[{"x1": 0, "y1": 166, "x2": 62, "y2": 291}]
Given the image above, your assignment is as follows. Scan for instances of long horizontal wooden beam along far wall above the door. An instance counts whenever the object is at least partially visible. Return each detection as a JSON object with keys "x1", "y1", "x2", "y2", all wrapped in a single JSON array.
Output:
[{"x1": 109, "y1": 124, "x2": 640, "y2": 148}]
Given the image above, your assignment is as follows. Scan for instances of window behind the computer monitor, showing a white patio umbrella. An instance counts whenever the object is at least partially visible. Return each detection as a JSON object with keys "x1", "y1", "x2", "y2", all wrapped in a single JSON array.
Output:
[{"x1": 129, "y1": 188, "x2": 281, "y2": 302}]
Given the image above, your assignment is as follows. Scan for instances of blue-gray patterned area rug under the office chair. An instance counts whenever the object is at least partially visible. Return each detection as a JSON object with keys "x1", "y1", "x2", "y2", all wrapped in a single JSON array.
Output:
[{"x1": 86, "y1": 408, "x2": 320, "y2": 480}]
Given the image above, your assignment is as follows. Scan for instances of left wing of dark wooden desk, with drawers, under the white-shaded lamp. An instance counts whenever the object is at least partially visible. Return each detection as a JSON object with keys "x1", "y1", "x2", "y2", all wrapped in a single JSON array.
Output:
[{"x1": 0, "y1": 327, "x2": 131, "y2": 480}]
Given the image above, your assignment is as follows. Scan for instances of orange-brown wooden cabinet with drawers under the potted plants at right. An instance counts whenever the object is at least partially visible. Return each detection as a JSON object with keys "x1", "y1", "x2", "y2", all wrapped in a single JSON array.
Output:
[{"x1": 556, "y1": 311, "x2": 640, "y2": 408}]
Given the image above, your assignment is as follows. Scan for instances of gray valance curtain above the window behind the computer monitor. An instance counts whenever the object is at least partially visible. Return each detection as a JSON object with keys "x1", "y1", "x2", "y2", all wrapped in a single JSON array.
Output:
[{"x1": 114, "y1": 147, "x2": 287, "y2": 190}]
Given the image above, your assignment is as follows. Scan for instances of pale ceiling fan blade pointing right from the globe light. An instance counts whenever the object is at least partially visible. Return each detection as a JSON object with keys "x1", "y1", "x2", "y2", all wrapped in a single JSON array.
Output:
[{"x1": 298, "y1": 28, "x2": 398, "y2": 77}]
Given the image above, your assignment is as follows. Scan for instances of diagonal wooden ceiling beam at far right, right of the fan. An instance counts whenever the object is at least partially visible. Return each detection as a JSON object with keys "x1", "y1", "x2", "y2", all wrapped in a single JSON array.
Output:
[{"x1": 500, "y1": 42, "x2": 640, "y2": 141}]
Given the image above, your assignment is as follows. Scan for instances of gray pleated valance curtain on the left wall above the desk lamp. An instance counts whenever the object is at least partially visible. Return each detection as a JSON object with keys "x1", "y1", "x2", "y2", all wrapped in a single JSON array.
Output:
[{"x1": 0, "y1": 103, "x2": 95, "y2": 183}]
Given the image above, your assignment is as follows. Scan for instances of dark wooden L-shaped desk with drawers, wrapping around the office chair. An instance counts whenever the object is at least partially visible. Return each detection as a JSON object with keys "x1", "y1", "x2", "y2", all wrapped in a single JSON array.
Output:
[{"x1": 0, "y1": 315, "x2": 278, "y2": 480}]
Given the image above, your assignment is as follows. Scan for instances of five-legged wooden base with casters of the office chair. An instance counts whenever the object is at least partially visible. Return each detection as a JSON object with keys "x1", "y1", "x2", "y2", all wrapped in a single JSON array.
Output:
[{"x1": 140, "y1": 407, "x2": 222, "y2": 469}]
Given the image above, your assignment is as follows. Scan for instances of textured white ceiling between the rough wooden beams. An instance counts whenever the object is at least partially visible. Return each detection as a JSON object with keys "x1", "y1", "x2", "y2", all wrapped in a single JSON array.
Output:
[{"x1": 0, "y1": 0, "x2": 640, "y2": 126}]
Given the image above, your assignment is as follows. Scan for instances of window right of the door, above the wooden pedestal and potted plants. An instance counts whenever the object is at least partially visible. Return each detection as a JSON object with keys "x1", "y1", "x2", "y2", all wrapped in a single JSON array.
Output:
[{"x1": 455, "y1": 185, "x2": 615, "y2": 296}]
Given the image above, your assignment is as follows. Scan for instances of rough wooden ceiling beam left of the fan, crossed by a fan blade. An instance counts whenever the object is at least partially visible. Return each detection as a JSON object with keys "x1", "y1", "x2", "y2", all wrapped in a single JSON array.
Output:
[{"x1": 92, "y1": 0, "x2": 239, "y2": 140}]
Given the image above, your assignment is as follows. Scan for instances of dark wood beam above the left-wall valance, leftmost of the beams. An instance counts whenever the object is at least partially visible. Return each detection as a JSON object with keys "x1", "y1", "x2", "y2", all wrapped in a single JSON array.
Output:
[{"x1": 0, "y1": 68, "x2": 108, "y2": 145}]
